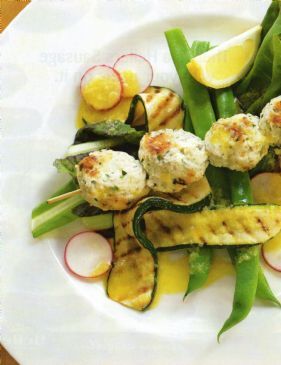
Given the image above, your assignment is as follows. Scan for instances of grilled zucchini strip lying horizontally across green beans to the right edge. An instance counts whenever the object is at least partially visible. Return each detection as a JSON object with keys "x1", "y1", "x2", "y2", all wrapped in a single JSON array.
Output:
[{"x1": 141, "y1": 201, "x2": 281, "y2": 250}]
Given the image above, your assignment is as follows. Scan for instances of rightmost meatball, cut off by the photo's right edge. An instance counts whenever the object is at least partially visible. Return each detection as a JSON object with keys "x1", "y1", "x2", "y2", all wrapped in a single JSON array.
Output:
[{"x1": 260, "y1": 95, "x2": 281, "y2": 145}]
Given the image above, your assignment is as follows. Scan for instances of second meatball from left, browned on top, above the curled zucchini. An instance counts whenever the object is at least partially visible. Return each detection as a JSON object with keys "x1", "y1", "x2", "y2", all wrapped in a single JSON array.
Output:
[{"x1": 139, "y1": 129, "x2": 208, "y2": 193}]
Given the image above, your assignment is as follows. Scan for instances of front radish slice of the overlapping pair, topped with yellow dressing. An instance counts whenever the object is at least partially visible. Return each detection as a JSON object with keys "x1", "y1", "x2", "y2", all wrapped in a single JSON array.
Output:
[{"x1": 80, "y1": 65, "x2": 123, "y2": 110}]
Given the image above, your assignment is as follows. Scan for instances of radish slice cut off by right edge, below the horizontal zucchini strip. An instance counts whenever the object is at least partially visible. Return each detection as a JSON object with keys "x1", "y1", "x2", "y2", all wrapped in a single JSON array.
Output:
[{"x1": 261, "y1": 233, "x2": 281, "y2": 272}]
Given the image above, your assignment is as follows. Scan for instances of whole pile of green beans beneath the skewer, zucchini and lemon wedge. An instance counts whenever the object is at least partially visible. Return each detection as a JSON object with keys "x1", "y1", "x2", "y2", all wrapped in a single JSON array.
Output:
[{"x1": 165, "y1": 24, "x2": 280, "y2": 341}]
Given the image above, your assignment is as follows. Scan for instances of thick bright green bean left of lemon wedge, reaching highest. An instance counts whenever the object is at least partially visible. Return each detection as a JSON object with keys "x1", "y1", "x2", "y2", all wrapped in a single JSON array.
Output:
[{"x1": 165, "y1": 29, "x2": 215, "y2": 138}]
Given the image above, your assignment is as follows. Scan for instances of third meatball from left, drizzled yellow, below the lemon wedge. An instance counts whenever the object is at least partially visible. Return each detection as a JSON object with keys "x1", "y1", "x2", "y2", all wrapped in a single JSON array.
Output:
[{"x1": 205, "y1": 114, "x2": 268, "y2": 171}]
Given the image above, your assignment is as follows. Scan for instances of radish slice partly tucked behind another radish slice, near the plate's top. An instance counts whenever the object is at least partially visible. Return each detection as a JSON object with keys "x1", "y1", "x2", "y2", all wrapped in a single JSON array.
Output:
[{"x1": 113, "y1": 53, "x2": 153, "y2": 97}]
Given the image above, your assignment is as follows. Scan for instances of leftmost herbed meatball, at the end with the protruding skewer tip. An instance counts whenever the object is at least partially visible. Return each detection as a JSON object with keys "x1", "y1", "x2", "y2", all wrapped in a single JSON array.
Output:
[{"x1": 76, "y1": 150, "x2": 149, "y2": 210}]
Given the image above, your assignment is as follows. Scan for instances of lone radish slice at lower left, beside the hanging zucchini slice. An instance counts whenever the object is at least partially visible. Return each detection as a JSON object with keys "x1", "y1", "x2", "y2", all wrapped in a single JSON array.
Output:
[{"x1": 64, "y1": 231, "x2": 112, "y2": 278}]
